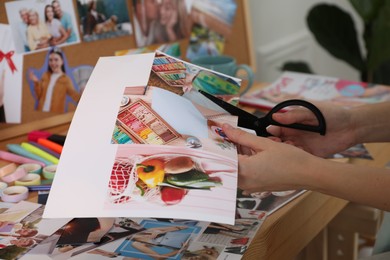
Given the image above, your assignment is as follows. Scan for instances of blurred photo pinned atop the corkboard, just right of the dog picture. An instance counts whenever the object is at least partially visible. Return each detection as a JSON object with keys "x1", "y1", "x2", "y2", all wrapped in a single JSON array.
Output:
[{"x1": 133, "y1": 0, "x2": 191, "y2": 47}]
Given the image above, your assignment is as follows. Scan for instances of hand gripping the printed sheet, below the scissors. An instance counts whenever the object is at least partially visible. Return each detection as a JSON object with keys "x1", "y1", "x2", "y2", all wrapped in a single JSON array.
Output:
[{"x1": 223, "y1": 124, "x2": 319, "y2": 193}]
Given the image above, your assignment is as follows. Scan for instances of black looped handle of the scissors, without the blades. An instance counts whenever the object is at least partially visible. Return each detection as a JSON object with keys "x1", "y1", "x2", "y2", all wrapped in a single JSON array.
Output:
[{"x1": 257, "y1": 99, "x2": 326, "y2": 136}]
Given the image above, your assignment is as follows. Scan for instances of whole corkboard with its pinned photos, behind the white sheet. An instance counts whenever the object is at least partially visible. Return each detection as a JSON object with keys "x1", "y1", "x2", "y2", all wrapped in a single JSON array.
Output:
[{"x1": 0, "y1": 0, "x2": 244, "y2": 125}]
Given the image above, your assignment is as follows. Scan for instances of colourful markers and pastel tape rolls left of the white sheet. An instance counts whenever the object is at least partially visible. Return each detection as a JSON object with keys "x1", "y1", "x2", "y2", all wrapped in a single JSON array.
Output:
[{"x1": 0, "y1": 131, "x2": 65, "y2": 202}]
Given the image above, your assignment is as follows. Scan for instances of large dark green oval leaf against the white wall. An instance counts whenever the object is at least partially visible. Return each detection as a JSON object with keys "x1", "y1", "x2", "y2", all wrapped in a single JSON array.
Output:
[{"x1": 307, "y1": 4, "x2": 366, "y2": 71}]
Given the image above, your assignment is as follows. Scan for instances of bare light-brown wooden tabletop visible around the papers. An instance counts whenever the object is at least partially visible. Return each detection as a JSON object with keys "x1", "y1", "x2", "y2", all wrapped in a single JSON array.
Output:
[{"x1": 0, "y1": 84, "x2": 390, "y2": 259}]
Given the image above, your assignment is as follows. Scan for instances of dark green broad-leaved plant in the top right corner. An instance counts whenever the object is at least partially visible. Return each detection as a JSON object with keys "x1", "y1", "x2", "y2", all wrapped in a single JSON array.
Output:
[{"x1": 284, "y1": 0, "x2": 390, "y2": 84}]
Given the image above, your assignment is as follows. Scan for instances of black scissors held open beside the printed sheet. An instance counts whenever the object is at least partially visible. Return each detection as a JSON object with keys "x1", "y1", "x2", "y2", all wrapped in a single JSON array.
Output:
[{"x1": 198, "y1": 90, "x2": 326, "y2": 137}]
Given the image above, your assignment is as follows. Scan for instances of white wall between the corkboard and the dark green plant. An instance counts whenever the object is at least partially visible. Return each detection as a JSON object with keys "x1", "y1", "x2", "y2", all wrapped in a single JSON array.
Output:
[{"x1": 247, "y1": 0, "x2": 362, "y2": 82}]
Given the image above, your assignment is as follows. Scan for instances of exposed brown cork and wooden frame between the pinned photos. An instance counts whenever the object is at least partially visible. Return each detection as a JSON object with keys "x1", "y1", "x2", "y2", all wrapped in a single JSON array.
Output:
[{"x1": 0, "y1": 0, "x2": 256, "y2": 128}]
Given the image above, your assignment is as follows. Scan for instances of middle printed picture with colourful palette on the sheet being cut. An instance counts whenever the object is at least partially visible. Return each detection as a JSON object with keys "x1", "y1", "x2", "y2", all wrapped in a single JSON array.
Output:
[{"x1": 111, "y1": 86, "x2": 237, "y2": 151}]
